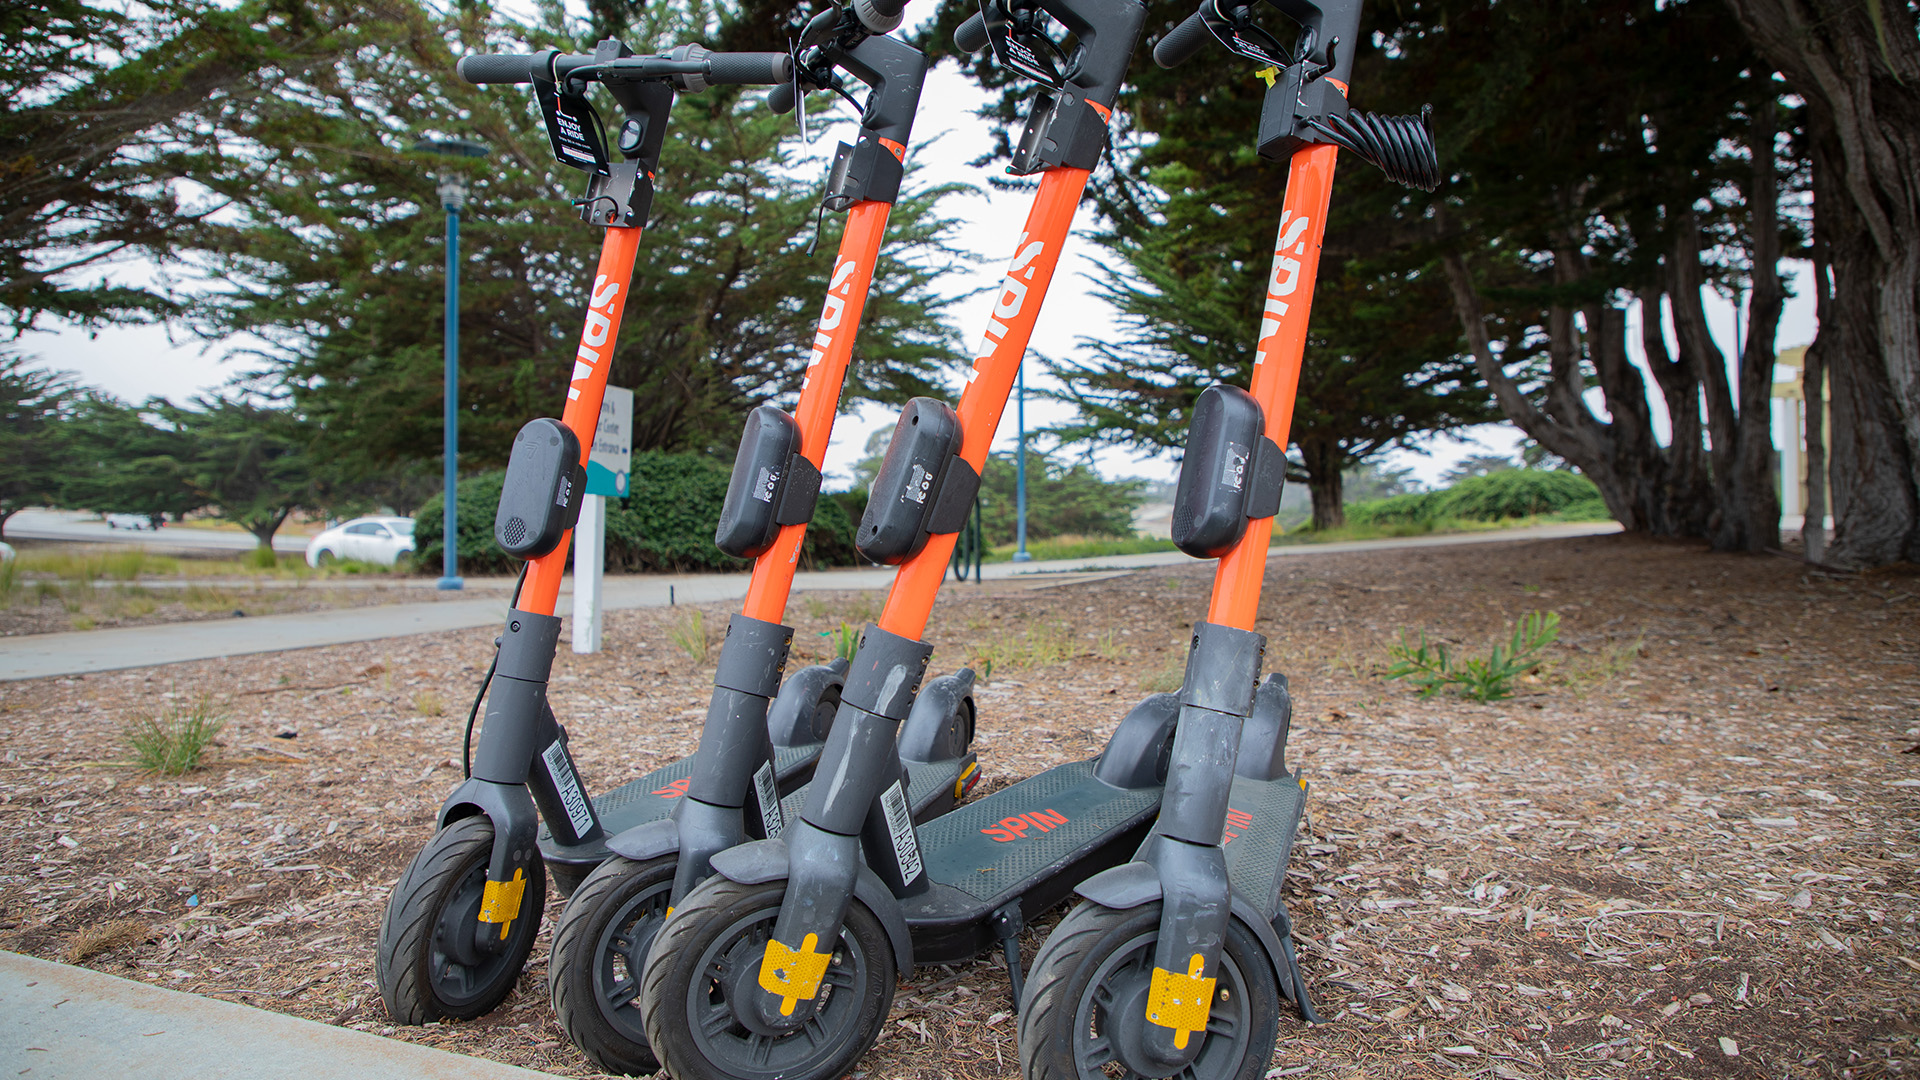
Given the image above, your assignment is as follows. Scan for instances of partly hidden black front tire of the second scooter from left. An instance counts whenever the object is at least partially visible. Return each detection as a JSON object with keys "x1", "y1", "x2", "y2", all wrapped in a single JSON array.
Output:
[{"x1": 547, "y1": 855, "x2": 680, "y2": 1076}]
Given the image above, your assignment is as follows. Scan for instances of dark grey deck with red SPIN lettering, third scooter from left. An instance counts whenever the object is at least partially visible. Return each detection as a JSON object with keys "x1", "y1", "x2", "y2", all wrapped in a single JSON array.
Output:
[{"x1": 900, "y1": 761, "x2": 1162, "y2": 965}]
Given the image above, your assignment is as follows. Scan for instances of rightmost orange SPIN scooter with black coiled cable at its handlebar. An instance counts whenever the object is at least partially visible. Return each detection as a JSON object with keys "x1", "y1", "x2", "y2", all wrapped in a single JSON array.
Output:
[{"x1": 1020, "y1": 0, "x2": 1440, "y2": 1080}]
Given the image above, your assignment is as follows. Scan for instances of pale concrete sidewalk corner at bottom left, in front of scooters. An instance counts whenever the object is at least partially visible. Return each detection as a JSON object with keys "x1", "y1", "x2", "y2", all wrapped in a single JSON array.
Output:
[{"x1": 0, "y1": 951, "x2": 553, "y2": 1080}]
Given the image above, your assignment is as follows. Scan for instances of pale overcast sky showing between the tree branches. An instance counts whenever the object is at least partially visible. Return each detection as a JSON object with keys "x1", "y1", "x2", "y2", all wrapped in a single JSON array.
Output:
[{"x1": 19, "y1": 10, "x2": 1814, "y2": 486}]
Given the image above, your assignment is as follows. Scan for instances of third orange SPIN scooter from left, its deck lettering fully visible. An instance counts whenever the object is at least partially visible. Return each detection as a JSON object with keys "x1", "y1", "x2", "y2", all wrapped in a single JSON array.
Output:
[{"x1": 641, "y1": 0, "x2": 1179, "y2": 1080}]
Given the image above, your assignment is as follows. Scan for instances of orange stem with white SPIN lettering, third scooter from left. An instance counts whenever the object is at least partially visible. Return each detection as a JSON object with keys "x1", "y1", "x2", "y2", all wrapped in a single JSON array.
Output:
[{"x1": 879, "y1": 161, "x2": 1108, "y2": 640}]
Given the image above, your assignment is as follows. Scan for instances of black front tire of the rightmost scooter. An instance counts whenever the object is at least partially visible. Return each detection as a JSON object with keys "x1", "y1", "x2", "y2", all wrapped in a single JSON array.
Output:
[{"x1": 1020, "y1": 901, "x2": 1281, "y2": 1080}]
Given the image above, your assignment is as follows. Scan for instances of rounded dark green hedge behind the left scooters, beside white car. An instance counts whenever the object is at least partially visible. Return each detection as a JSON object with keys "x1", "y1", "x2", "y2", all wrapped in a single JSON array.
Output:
[{"x1": 413, "y1": 452, "x2": 871, "y2": 575}]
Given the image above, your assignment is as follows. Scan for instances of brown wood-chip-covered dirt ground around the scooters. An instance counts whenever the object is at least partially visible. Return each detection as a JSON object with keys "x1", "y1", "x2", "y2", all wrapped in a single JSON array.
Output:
[{"x1": 0, "y1": 536, "x2": 1920, "y2": 1080}]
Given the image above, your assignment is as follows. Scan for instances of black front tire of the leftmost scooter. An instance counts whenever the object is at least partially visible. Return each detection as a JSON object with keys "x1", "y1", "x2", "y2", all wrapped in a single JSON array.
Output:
[{"x1": 374, "y1": 815, "x2": 547, "y2": 1024}]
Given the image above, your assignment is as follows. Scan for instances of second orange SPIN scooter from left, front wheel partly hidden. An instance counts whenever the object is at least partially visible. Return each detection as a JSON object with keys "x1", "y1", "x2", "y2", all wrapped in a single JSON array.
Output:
[{"x1": 547, "y1": 8, "x2": 979, "y2": 1074}]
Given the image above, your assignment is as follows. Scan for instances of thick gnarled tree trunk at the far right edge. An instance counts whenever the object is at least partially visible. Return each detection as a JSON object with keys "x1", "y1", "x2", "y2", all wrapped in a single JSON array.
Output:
[{"x1": 1728, "y1": 0, "x2": 1920, "y2": 565}]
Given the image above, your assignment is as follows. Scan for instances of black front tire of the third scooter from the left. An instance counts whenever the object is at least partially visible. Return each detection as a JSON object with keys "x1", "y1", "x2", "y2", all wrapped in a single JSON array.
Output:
[{"x1": 639, "y1": 874, "x2": 897, "y2": 1080}]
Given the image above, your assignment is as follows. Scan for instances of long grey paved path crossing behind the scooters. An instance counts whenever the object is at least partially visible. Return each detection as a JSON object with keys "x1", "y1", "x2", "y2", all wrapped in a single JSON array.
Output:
[{"x1": 0, "y1": 521, "x2": 1620, "y2": 680}]
